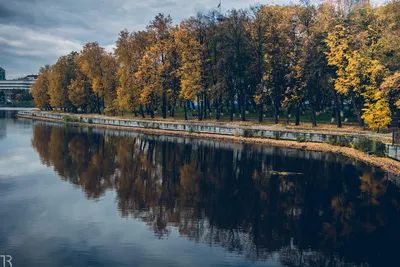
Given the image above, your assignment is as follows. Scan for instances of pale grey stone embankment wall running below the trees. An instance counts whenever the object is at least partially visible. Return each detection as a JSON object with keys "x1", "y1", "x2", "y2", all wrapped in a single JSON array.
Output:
[{"x1": 18, "y1": 111, "x2": 400, "y2": 161}]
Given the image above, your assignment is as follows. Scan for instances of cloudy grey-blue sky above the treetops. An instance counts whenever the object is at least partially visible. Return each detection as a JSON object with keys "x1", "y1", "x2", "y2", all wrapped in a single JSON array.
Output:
[{"x1": 0, "y1": 0, "x2": 382, "y2": 79}]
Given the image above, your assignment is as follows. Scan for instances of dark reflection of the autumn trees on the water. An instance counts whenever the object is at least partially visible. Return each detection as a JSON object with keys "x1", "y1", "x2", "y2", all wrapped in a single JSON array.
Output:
[{"x1": 32, "y1": 124, "x2": 400, "y2": 266}]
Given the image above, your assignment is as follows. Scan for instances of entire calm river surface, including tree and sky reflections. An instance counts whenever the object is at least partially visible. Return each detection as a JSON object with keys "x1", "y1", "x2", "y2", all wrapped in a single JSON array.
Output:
[{"x1": 0, "y1": 111, "x2": 400, "y2": 267}]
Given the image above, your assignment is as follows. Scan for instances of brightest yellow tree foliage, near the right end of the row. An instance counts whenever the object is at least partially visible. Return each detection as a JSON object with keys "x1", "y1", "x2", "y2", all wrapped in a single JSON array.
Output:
[{"x1": 326, "y1": 22, "x2": 390, "y2": 129}]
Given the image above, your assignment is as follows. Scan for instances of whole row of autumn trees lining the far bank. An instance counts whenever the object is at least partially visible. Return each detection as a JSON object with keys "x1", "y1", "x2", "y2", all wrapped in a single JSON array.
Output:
[{"x1": 32, "y1": 0, "x2": 400, "y2": 129}]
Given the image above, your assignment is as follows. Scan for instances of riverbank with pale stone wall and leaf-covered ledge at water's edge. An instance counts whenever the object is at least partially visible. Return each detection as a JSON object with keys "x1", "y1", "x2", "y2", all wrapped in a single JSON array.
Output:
[{"x1": 18, "y1": 111, "x2": 400, "y2": 175}]
